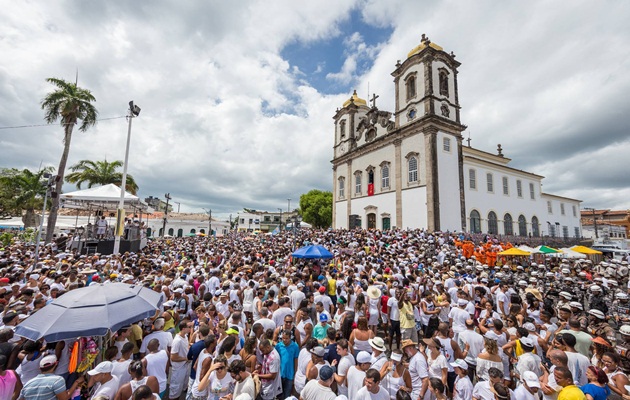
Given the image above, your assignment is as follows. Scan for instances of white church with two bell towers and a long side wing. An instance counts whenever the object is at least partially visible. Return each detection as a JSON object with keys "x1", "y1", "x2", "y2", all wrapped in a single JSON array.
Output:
[{"x1": 331, "y1": 35, "x2": 581, "y2": 238}]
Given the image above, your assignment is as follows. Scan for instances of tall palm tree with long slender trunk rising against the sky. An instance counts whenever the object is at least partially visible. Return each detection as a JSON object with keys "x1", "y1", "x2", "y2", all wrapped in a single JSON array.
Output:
[{"x1": 41, "y1": 78, "x2": 98, "y2": 243}]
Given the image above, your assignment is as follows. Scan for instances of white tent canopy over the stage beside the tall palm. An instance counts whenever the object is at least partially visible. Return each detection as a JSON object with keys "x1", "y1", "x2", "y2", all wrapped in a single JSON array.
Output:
[{"x1": 59, "y1": 183, "x2": 149, "y2": 211}]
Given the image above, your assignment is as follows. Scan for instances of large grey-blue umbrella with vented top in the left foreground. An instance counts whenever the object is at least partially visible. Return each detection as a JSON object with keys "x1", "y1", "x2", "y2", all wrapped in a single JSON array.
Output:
[{"x1": 15, "y1": 283, "x2": 162, "y2": 342}]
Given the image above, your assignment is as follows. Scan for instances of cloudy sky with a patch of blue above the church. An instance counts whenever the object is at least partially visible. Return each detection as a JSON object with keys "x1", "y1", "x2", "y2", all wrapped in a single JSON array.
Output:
[{"x1": 0, "y1": 0, "x2": 630, "y2": 216}]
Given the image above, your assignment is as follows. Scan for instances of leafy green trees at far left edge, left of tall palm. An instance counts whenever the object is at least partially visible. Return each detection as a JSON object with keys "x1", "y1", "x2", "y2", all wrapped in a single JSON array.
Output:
[{"x1": 0, "y1": 167, "x2": 53, "y2": 228}]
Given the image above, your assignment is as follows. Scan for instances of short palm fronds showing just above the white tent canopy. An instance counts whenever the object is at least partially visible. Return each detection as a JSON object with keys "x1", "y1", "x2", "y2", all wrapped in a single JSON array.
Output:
[{"x1": 66, "y1": 160, "x2": 138, "y2": 194}]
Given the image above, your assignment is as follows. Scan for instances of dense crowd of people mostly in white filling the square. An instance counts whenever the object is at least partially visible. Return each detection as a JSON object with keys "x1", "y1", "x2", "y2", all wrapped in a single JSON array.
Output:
[{"x1": 0, "y1": 229, "x2": 630, "y2": 400}]
